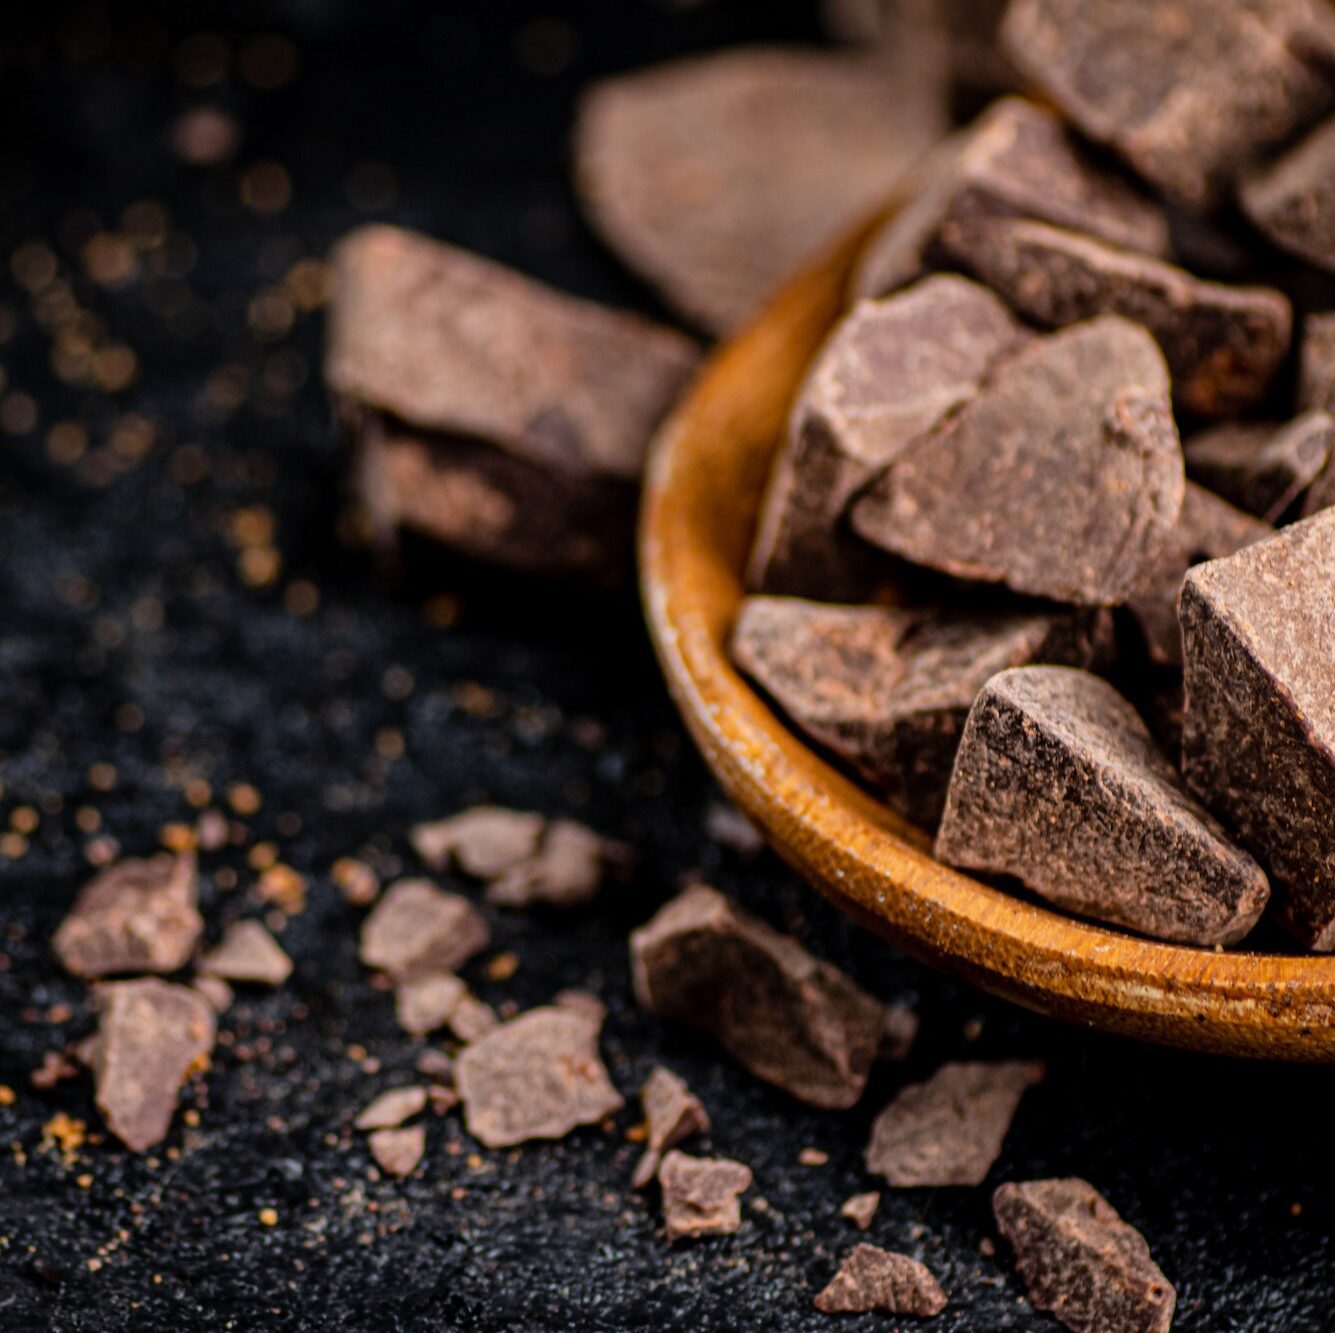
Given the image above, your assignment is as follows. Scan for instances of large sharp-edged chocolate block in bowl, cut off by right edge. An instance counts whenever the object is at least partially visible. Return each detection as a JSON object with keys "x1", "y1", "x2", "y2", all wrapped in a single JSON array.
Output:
[{"x1": 1180, "y1": 510, "x2": 1335, "y2": 951}]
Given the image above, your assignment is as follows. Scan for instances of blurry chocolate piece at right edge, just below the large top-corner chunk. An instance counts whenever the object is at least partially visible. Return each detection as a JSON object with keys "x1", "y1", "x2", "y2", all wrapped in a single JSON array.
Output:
[{"x1": 1239, "y1": 117, "x2": 1335, "y2": 272}]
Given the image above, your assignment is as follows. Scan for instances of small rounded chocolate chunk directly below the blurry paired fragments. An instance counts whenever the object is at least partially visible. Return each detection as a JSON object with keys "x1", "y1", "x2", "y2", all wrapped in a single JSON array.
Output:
[{"x1": 360, "y1": 879, "x2": 491, "y2": 981}]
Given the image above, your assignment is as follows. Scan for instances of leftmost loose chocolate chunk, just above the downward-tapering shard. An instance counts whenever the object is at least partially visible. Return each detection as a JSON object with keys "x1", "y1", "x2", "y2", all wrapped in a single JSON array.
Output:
[{"x1": 52, "y1": 855, "x2": 204, "y2": 977}]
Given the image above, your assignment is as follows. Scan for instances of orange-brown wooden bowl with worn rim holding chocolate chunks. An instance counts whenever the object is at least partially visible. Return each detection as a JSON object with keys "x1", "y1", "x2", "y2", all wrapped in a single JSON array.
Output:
[{"x1": 639, "y1": 218, "x2": 1335, "y2": 1061}]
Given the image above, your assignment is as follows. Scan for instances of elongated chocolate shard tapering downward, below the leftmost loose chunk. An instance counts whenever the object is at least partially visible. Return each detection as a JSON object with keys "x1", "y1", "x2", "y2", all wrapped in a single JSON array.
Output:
[{"x1": 89, "y1": 978, "x2": 216, "y2": 1153}]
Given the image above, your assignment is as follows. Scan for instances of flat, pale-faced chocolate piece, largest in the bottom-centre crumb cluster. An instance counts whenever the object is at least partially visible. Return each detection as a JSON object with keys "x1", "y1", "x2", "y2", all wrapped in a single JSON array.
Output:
[{"x1": 455, "y1": 1006, "x2": 623, "y2": 1148}]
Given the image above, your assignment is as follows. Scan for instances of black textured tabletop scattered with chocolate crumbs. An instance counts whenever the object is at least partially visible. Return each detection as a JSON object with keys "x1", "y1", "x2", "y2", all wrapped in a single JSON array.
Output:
[{"x1": 0, "y1": 0, "x2": 1335, "y2": 1333}]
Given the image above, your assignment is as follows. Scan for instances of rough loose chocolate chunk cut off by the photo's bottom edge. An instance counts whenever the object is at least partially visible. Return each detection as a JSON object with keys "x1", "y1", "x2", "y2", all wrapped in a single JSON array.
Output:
[{"x1": 992, "y1": 1178, "x2": 1177, "y2": 1333}]
